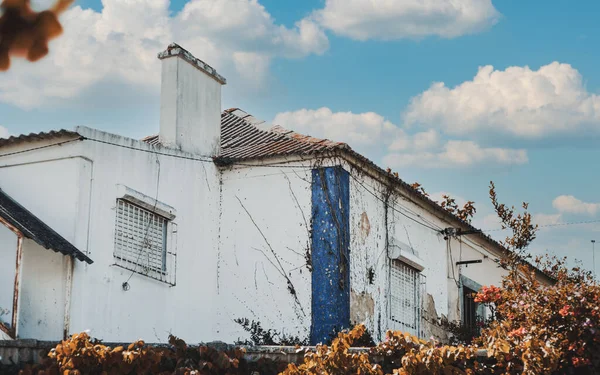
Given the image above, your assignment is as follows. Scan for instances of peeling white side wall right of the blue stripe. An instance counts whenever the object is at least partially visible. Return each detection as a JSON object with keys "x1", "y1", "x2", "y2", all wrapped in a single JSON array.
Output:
[{"x1": 345, "y1": 164, "x2": 505, "y2": 339}]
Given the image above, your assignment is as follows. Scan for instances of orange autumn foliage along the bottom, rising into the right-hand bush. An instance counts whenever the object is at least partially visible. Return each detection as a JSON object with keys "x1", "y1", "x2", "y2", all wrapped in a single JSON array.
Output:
[{"x1": 8, "y1": 184, "x2": 600, "y2": 375}]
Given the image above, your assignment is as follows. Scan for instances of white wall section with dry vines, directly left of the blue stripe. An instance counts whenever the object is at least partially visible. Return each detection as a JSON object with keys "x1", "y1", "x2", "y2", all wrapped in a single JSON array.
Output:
[{"x1": 217, "y1": 163, "x2": 311, "y2": 341}]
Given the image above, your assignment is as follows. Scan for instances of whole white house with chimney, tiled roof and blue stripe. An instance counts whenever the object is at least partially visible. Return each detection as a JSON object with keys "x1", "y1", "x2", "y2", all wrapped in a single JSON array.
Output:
[{"x1": 0, "y1": 44, "x2": 552, "y2": 343}]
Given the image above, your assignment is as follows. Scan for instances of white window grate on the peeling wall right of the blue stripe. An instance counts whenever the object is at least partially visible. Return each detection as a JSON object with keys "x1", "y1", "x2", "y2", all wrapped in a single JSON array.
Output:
[{"x1": 390, "y1": 259, "x2": 422, "y2": 335}]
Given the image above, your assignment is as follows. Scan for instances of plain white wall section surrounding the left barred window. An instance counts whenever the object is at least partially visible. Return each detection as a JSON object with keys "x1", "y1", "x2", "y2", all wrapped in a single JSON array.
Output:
[{"x1": 66, "y1": 129, "x2": 219, "y2": 342}]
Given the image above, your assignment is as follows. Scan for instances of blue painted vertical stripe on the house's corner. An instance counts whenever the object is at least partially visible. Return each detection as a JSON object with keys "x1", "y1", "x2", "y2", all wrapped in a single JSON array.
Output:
[{"x1": 310, "y1": 167, "x2": 350, "y2": 345}]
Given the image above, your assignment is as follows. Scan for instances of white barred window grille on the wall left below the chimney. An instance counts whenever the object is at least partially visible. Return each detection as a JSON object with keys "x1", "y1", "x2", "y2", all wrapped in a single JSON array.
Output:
[{"x1": 114, "y1": 199, "x2": 175, "y2": 285}]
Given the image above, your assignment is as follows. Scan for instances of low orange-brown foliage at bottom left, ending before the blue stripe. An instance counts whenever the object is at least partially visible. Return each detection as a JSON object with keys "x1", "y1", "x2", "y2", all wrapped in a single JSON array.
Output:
[{"x1": 19, "y1": 333, "x2": 285, "y2": 375}]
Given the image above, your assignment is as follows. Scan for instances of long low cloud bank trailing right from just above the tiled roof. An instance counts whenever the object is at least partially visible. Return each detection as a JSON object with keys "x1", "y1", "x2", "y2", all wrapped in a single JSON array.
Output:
[{"x1": 273, "y1": 107, "x2": 528, "y2": 168}]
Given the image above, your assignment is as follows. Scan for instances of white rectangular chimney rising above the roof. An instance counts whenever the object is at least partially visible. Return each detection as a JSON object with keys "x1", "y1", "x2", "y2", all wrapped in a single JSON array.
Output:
[{"x1": 158, "y1": 43, "x2": 226, "y2": 156}]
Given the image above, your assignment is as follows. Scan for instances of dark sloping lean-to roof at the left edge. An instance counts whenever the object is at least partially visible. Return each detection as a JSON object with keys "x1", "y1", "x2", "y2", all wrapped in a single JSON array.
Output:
[{"x1": 0, "y1": 189, "x2": 93, "y2": 264}]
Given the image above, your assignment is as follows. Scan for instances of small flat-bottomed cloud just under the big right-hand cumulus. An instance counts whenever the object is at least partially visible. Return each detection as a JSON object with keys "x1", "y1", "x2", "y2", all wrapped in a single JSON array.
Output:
[{"x1": 384, "y1": 140, "x2": 528, "y2": 168}]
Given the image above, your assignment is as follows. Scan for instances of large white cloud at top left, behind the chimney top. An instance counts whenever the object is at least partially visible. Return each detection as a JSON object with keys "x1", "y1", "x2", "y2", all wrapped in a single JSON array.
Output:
[{"x1": 0, "y1": 0, "x2": 329, "y2": 109}]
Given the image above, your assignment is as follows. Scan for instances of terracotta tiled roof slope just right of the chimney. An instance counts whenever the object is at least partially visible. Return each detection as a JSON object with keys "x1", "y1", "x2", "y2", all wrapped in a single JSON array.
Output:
[{"x1": 142, "y1": 108, "x2": 350, "y2": 163}]
